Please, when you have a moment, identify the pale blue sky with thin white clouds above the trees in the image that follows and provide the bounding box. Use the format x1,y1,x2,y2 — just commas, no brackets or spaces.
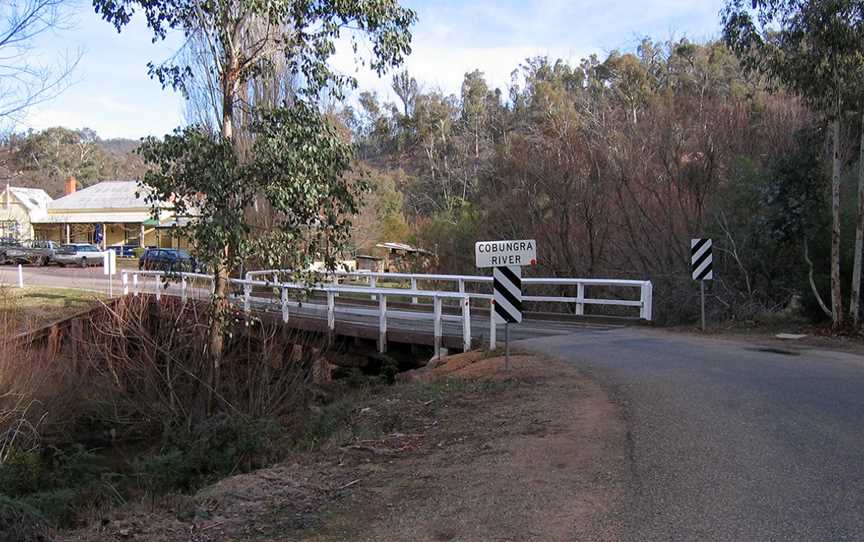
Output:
17,0,723,139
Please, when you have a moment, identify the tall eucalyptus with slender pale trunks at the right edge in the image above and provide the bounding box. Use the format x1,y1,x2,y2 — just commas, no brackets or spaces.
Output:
723,0,864,326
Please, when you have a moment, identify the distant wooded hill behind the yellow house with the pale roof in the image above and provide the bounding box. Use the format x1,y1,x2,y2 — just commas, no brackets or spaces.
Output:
0,127,144,198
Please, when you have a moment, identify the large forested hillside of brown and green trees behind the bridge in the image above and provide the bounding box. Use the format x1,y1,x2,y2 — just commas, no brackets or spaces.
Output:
346,40,840,328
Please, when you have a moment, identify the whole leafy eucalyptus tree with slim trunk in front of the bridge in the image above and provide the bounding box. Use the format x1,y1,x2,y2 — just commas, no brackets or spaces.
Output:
93,0,416,366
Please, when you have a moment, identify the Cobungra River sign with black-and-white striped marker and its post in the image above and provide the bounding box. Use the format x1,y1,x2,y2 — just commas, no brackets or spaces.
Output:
474,239,537,370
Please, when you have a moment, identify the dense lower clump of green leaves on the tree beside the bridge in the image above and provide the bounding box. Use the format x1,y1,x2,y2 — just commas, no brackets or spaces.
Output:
139,101,366,269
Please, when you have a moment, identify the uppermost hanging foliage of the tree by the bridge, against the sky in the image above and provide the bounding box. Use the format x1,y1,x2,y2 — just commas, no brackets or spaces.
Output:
93,0,417,96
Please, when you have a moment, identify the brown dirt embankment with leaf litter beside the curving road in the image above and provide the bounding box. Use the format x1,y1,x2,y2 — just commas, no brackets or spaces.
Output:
64,354,626,542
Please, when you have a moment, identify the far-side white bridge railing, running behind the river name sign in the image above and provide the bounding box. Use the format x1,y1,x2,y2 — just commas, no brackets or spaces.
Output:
246,269,654,321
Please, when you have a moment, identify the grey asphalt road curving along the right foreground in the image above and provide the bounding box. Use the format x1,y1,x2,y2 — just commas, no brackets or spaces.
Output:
518,328,864,542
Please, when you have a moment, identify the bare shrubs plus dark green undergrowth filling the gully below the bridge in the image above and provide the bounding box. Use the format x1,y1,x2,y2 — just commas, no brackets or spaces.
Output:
0,288,460,540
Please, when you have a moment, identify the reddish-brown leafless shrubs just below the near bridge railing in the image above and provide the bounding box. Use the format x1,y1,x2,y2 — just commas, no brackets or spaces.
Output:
0,296,321,462
